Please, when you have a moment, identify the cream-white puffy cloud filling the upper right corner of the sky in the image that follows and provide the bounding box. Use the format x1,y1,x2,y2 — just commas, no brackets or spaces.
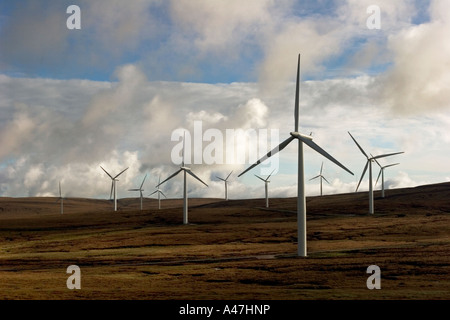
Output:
380,0,450,113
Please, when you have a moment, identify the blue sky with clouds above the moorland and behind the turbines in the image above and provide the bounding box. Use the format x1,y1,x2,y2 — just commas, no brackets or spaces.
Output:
0,0,450,199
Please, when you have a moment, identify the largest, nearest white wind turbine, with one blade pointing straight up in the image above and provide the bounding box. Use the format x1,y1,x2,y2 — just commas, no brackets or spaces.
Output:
239,54,353,257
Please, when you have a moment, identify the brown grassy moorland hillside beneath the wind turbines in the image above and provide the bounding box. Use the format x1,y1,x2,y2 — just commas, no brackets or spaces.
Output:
0,183,450,300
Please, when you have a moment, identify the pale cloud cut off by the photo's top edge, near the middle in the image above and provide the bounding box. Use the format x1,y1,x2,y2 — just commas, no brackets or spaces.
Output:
167,0,276,59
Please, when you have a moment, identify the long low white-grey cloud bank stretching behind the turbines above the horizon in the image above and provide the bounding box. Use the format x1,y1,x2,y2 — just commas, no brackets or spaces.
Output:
0,65,450,197
